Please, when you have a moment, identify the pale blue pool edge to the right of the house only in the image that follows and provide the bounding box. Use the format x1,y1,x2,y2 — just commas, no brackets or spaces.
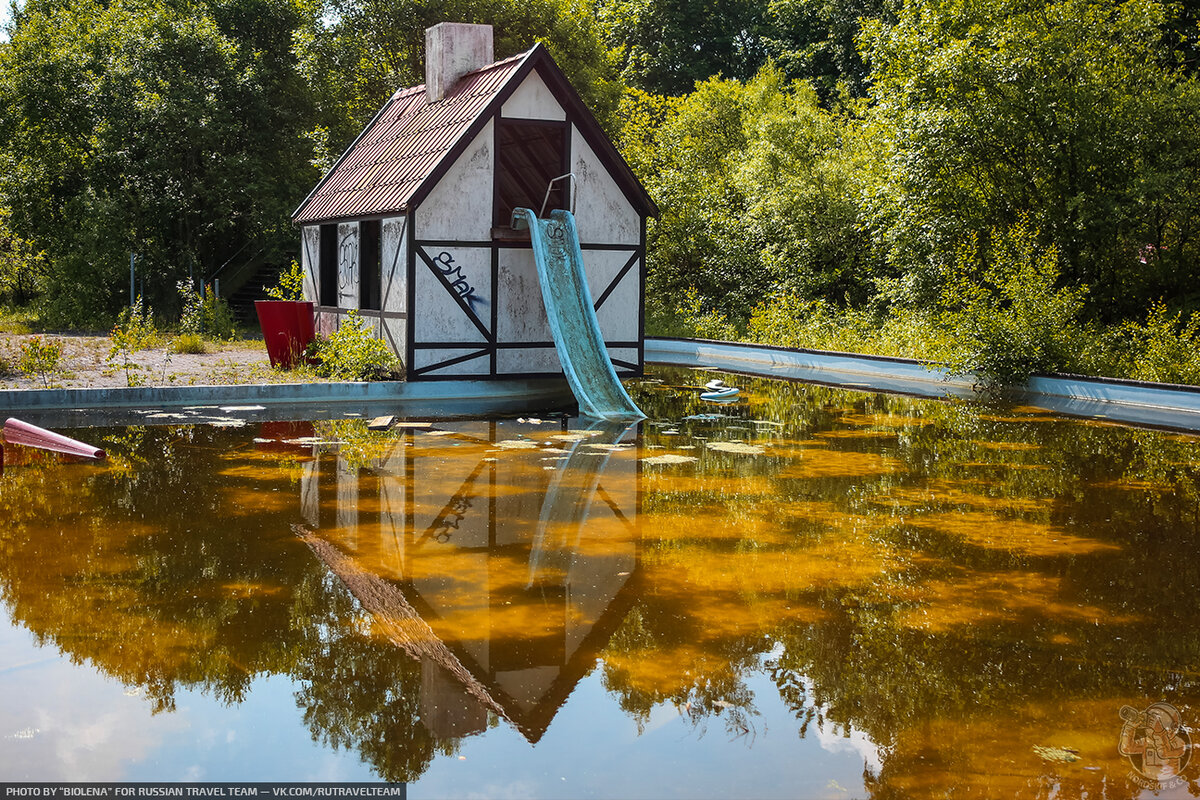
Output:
646,337,1200,431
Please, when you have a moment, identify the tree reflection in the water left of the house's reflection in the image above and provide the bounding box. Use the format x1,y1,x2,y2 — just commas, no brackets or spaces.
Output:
0,427,452,780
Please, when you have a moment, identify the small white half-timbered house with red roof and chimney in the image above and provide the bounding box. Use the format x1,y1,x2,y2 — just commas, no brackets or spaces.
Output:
293,23,656,380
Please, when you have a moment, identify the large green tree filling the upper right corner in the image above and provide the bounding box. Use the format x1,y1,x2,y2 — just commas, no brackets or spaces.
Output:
866,0,1200,317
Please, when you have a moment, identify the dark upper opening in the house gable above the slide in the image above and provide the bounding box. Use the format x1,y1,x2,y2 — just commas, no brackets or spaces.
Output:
492,119,570,228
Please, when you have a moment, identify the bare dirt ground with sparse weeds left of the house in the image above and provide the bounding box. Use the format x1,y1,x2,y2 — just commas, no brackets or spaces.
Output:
0,333,283,390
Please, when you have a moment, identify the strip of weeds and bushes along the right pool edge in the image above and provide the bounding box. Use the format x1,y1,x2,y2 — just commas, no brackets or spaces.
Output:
647,223,1200,389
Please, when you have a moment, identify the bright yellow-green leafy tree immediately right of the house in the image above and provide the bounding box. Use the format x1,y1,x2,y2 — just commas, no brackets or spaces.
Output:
622,66,884,324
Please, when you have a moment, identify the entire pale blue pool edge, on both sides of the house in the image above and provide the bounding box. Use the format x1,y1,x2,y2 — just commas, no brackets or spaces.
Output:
0,337,1200,431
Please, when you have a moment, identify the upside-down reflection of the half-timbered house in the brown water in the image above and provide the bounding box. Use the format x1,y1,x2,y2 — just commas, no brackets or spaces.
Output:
301,422,638,741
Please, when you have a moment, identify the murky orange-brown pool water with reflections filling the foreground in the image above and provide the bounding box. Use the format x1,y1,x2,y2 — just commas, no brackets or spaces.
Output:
0,371,1200,798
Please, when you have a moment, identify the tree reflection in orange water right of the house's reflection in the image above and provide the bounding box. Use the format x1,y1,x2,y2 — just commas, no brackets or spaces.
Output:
619,374,1200,796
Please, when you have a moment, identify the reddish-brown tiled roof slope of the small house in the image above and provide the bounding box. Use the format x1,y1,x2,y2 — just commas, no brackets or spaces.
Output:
292,50,534,224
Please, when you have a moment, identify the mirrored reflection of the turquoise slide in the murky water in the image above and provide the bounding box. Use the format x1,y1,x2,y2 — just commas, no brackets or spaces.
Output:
526,421,636,588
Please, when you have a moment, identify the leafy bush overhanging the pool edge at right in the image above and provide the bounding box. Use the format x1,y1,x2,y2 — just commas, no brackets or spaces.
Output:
941,223,1087,386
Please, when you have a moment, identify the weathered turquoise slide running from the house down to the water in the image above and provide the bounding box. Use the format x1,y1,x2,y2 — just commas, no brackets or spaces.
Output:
512,209,646,420
